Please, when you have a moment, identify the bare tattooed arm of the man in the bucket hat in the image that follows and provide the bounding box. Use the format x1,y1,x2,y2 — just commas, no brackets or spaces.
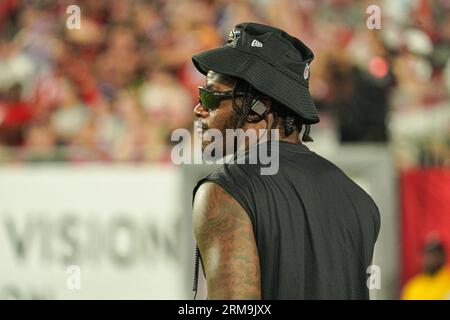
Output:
192,182,261,299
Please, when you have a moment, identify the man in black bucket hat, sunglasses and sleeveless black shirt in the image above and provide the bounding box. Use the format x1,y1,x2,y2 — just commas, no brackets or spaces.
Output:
192,23,380,299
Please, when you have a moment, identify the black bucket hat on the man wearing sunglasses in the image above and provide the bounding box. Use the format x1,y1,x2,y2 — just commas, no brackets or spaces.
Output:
192,22,319,124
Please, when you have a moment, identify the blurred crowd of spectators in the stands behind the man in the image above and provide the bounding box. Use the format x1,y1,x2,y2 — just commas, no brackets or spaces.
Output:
0,0,450,164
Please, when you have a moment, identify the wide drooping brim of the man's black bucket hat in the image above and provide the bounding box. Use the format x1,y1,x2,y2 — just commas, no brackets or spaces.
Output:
192,45,319,124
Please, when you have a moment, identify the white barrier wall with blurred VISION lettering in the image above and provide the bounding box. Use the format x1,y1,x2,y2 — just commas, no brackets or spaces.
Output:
0,165,186,299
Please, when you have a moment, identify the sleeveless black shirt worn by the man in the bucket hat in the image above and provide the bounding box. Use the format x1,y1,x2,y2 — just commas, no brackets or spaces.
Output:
194,141,380,299
